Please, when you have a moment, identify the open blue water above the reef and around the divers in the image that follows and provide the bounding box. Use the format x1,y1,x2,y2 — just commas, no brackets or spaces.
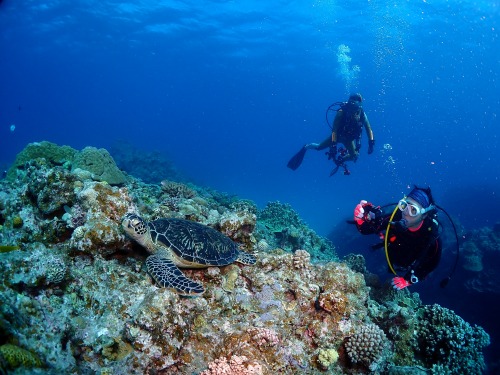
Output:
0,0,500,370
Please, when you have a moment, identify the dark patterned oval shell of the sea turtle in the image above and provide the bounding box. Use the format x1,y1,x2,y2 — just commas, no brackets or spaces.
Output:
148,219,240,266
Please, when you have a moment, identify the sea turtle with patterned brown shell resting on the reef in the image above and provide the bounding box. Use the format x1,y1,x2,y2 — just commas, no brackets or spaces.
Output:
122,214,256,295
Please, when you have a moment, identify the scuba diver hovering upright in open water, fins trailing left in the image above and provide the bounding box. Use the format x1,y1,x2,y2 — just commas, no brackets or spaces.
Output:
288,93,375,176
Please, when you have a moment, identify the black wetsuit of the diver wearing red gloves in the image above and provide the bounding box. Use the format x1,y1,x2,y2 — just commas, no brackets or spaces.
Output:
356,210,442,282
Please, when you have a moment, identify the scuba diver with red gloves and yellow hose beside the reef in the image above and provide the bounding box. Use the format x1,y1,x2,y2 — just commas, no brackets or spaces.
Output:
354,186,444,290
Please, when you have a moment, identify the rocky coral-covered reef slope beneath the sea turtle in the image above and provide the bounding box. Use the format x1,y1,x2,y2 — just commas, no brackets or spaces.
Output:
0,142,489,375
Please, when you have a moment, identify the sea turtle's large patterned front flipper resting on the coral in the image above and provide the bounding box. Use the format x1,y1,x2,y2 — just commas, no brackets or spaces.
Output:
146,254,205,296
